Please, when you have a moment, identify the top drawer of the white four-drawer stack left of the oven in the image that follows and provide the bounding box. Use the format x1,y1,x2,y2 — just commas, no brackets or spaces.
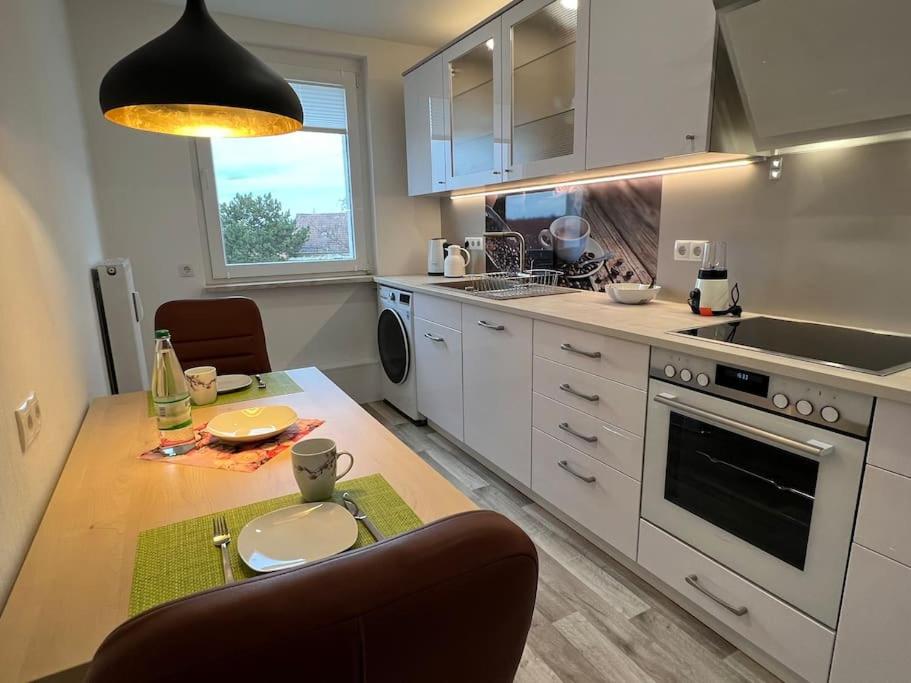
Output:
535,321,649,389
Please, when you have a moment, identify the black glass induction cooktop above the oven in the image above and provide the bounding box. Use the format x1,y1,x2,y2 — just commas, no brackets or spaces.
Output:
675,316,911,375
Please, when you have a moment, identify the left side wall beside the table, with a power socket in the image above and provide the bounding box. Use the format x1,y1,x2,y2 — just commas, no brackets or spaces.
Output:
0,0,106,604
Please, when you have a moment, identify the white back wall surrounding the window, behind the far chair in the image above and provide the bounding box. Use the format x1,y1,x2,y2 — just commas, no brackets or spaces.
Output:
68,0,440,400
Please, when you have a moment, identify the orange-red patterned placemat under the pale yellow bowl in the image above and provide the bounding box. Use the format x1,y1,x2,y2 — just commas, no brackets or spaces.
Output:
139,419,323,472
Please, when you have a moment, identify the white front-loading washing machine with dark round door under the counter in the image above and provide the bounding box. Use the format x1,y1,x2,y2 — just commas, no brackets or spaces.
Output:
376,285,424,422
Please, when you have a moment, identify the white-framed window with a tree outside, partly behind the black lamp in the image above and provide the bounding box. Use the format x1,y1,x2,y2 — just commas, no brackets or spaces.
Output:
196,58,369,280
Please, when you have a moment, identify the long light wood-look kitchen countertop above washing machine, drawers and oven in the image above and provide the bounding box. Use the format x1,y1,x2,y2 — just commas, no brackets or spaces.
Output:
374,275,911,403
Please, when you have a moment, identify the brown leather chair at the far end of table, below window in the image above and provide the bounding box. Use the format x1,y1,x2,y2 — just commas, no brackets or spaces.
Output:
155,296,272,375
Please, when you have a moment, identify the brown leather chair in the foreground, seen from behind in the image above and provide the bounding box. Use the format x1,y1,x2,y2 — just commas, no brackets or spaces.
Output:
86,510,538,683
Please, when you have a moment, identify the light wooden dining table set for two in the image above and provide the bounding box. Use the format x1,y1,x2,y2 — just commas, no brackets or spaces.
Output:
0,368,475,681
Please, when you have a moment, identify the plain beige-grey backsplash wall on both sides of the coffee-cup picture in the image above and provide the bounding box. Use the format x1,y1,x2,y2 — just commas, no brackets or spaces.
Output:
442,141,911,333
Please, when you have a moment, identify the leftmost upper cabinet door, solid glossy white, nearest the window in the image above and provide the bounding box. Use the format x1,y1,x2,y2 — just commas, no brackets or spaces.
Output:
405,55,449,197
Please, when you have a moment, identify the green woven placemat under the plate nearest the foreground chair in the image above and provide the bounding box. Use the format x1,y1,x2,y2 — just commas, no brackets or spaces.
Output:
129,474,423,617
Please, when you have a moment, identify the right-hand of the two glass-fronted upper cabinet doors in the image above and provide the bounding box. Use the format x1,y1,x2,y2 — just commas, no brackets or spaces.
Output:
501,0,589,180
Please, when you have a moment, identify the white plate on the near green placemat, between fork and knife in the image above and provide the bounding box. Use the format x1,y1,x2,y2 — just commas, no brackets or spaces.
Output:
237,503,357,572
